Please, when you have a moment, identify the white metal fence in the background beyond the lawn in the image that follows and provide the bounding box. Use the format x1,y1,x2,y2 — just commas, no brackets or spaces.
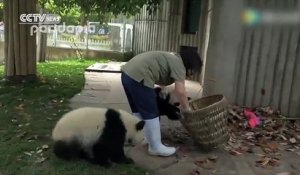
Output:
0,22,133,52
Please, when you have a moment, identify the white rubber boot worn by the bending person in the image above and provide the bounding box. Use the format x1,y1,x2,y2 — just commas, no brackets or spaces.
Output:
144,117,176,156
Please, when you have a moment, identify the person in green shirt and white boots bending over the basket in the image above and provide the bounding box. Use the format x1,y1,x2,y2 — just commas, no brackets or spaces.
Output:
121,51,202,156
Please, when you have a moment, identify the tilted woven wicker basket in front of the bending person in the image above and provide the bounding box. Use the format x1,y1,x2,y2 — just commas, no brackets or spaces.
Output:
180,95,229,150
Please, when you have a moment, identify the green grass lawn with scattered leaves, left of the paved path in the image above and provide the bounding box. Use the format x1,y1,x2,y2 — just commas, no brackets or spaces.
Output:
0,60,145,175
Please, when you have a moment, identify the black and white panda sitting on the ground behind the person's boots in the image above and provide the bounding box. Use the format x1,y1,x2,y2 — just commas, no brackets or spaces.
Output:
52,107,145,167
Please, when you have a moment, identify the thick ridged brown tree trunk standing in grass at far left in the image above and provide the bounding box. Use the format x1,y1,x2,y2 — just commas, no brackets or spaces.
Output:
4,0,36,83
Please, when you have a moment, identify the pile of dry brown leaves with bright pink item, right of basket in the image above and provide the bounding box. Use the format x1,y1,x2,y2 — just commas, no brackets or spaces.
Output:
225,106,300,168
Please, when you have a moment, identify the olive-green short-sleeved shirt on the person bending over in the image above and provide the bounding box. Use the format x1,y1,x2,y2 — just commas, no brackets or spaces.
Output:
121,51,185,88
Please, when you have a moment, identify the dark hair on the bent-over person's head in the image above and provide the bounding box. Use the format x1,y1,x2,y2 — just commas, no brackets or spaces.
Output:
179,50,203,76
